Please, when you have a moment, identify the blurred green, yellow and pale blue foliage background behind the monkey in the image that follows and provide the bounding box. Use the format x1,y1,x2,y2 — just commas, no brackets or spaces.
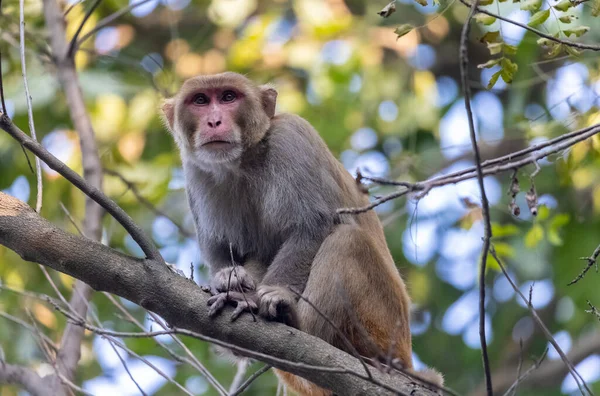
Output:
0,0,600,395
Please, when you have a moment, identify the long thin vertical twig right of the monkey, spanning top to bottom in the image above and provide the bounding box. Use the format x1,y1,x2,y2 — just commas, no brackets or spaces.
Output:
460,0,494,396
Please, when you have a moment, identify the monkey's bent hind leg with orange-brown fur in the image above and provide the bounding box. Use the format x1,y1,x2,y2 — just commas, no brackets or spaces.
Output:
278,225,412,396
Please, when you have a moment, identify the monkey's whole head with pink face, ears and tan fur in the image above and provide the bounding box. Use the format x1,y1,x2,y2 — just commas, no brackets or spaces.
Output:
162,72,277,169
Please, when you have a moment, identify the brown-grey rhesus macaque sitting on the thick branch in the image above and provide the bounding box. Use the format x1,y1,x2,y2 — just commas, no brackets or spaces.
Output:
163,72,443,396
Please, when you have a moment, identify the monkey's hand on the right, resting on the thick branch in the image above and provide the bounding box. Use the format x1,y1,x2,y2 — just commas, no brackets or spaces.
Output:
257,285,298,328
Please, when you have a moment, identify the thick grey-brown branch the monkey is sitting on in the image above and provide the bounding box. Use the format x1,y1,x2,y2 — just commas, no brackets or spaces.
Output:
0,193,435,395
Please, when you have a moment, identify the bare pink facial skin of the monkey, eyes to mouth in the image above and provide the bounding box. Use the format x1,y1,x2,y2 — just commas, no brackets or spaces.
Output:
185,88,244,154
